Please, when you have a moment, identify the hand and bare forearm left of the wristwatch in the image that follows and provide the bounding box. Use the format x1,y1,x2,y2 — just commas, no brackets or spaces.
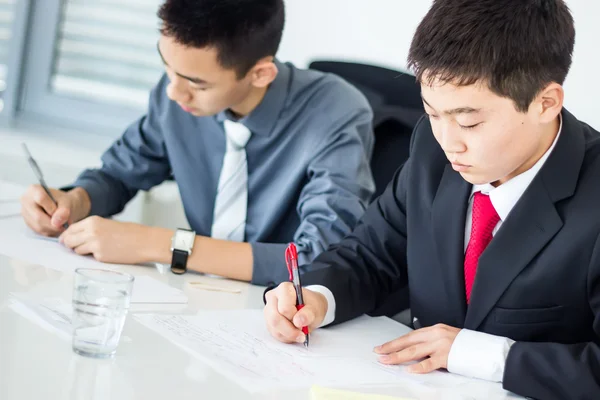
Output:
59,216,159,264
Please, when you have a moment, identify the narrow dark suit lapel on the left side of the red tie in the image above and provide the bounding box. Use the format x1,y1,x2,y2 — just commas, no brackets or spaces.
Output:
432,165,472,327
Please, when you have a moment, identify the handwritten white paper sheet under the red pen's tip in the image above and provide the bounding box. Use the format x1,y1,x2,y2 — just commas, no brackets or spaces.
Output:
134,310,494,392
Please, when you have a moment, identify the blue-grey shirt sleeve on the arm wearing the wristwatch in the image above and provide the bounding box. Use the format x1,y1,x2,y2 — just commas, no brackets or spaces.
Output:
252,94,375,285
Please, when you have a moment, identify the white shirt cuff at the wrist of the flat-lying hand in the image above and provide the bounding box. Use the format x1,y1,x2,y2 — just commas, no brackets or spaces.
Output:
448,329,515,382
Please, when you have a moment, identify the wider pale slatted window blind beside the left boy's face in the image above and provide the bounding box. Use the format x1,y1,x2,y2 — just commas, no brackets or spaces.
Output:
50,0,163,108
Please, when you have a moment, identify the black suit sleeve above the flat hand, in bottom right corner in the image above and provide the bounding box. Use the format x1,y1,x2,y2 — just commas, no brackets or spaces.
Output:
503,236,600,400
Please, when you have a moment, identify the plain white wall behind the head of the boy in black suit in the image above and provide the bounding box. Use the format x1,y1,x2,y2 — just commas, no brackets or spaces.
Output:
279,0,600,129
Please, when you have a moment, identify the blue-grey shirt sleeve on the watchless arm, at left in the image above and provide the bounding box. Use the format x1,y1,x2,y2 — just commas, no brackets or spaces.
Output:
72,76,171,217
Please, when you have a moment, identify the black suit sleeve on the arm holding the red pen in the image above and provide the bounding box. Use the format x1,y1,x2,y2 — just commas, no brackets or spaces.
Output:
302,117,418,323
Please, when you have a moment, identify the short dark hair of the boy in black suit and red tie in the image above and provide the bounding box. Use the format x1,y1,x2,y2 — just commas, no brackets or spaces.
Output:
408,0,575,112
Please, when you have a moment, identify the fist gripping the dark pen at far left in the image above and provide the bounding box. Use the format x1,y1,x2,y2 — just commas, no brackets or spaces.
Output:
21,185,91,236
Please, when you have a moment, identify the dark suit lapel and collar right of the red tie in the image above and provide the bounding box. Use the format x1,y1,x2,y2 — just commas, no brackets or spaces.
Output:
464,109,585,330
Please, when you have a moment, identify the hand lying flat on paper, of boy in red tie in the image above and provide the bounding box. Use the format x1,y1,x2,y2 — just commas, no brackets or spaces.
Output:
374,324,460,374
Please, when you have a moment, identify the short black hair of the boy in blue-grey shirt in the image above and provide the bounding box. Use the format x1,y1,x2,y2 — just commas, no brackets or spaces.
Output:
158,0,285,78
